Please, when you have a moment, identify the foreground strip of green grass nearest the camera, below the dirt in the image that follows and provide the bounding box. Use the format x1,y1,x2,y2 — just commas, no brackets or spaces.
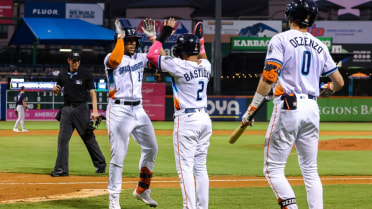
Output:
0,185,372,209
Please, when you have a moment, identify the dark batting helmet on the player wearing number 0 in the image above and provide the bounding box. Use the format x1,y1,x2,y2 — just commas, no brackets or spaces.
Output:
285,0,318,27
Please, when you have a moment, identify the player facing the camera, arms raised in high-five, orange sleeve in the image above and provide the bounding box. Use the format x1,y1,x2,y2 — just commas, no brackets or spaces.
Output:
104,19,165,209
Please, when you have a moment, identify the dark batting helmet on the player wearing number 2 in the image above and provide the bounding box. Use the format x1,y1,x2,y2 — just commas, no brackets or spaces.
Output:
173,34,200,57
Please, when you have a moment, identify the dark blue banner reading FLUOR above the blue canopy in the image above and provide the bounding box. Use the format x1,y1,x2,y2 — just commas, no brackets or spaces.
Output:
24,1,66,18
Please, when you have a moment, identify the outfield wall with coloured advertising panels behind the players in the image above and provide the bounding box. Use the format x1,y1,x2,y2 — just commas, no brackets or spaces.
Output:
0,85,372,122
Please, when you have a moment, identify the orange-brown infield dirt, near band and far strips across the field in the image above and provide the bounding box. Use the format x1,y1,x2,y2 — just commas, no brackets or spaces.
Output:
0,130,372,203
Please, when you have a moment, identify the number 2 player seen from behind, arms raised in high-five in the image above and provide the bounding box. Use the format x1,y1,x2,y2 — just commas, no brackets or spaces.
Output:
147,18,212,209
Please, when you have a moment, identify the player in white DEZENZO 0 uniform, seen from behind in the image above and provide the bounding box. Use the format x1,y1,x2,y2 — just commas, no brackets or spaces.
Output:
242,0,344,209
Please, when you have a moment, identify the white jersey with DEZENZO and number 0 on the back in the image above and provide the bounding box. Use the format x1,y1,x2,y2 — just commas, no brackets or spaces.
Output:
265,30,337,96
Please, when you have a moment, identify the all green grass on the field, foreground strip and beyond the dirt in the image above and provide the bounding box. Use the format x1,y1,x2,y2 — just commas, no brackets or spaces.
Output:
0,121,372,209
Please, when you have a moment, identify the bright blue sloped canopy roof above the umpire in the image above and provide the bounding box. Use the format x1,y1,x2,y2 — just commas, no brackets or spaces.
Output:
9,17,115,64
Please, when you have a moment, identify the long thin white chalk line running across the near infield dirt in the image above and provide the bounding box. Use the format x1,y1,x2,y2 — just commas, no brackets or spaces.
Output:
0,177,372,185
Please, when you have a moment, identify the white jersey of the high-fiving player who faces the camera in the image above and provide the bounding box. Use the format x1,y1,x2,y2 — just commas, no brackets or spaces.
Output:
104,53,148,101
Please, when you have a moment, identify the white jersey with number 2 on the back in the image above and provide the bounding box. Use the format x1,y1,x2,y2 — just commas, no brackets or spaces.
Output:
159,56,211,110
